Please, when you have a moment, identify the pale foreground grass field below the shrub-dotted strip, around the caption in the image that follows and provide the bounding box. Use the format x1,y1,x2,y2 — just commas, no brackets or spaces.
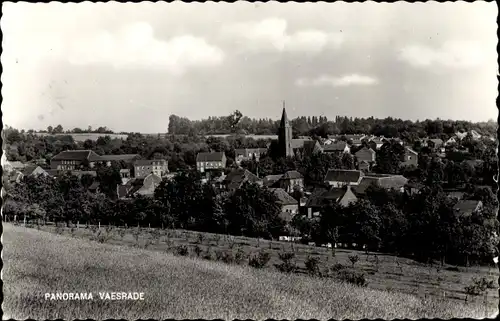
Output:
2,223,496,319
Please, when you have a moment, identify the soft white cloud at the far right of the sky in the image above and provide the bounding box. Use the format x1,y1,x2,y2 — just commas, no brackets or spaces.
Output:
399,41,486,68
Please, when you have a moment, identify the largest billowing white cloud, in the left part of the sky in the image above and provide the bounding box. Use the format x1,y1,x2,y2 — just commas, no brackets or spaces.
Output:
69,22,224,73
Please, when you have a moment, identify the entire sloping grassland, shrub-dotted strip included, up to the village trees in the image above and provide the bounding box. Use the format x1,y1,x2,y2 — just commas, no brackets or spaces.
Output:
2,223,498,319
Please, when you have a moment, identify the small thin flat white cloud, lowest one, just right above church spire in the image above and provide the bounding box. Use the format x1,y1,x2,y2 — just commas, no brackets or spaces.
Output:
295,74,378,87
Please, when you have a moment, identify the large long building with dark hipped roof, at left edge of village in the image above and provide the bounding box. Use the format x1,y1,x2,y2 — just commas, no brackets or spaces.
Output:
50,150,101,171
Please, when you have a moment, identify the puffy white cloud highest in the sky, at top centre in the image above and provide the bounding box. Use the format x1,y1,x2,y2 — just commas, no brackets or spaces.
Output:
221,18,343,53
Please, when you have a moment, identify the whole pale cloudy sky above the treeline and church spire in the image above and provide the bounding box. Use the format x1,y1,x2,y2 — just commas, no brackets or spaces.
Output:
0,1,498,133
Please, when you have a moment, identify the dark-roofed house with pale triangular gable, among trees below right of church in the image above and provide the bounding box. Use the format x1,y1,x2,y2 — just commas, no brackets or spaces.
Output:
304,185,358,218
